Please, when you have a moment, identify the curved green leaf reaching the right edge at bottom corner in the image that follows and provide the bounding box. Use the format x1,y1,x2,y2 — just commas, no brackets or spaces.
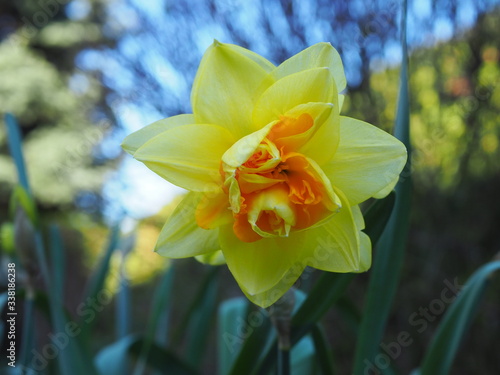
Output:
420,261,500,375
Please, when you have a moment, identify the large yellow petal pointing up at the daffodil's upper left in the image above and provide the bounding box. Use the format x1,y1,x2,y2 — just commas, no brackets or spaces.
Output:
191,42,273,138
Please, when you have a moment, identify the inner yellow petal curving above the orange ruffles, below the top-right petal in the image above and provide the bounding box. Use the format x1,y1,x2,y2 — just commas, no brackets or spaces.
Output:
253,68,338,130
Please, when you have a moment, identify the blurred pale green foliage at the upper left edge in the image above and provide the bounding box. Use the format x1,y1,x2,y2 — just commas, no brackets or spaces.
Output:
0,7,111,207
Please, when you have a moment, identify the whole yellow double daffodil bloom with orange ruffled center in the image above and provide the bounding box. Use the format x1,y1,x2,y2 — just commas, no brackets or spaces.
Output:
123,41,406,307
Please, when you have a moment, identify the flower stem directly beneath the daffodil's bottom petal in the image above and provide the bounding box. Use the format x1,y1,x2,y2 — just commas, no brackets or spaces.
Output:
268,289,295,375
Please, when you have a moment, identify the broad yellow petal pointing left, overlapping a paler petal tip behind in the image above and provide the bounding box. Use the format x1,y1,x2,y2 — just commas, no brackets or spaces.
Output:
134,124,234,191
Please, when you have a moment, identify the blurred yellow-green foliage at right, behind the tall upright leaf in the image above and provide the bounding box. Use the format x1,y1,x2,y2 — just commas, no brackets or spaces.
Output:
346,10,500,191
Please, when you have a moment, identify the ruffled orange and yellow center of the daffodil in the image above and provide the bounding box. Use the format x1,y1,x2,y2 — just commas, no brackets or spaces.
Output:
215,113,340,242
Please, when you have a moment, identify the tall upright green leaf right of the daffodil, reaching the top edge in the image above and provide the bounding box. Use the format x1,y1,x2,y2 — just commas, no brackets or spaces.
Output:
354,0,411,375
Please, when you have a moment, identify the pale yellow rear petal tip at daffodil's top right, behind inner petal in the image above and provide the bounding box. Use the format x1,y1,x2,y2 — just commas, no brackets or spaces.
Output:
273,43,346,92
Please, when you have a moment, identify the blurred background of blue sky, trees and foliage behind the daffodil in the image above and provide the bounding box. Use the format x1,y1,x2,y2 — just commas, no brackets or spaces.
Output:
0,0,500,374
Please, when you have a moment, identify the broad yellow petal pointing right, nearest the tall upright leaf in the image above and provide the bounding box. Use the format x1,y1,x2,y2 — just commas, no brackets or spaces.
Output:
321,116,407,205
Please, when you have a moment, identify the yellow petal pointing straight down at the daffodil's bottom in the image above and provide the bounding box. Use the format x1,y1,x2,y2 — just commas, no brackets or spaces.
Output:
219,225,306,295
